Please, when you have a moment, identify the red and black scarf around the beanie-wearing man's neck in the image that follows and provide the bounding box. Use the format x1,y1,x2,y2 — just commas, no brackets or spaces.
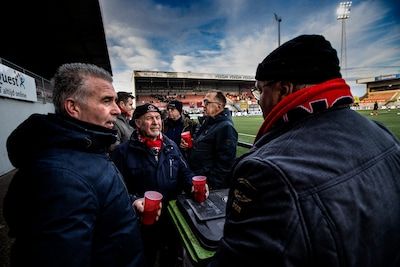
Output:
255,78,353,141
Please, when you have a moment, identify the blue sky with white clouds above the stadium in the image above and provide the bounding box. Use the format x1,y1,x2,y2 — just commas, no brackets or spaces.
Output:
100,0,400,96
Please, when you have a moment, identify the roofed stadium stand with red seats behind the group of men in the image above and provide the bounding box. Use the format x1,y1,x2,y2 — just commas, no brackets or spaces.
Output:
133,71,255,114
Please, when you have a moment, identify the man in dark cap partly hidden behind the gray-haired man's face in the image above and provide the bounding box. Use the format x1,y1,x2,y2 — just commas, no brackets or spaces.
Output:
114,92,135,149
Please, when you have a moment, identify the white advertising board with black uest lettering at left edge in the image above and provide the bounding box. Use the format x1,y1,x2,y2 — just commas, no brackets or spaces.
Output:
0,64,37,102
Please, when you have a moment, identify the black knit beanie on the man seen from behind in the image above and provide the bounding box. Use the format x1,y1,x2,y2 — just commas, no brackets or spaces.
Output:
256,35,342,84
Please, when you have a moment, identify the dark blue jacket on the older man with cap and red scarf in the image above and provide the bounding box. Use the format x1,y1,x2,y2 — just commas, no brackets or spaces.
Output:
111,130,193,204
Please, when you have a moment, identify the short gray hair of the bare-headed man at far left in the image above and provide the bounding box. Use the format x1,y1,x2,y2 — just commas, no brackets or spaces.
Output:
51,63,113,114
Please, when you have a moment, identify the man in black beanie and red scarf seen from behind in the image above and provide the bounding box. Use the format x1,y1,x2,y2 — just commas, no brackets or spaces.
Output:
209,35,400,267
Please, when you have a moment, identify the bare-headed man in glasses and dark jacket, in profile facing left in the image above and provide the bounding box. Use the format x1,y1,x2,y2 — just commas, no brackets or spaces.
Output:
187,91,238,190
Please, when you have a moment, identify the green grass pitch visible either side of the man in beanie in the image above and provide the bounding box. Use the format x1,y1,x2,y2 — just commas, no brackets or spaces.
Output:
233,110,400,156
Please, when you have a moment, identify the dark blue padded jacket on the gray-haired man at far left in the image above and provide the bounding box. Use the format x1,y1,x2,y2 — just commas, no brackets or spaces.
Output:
4,114,143,267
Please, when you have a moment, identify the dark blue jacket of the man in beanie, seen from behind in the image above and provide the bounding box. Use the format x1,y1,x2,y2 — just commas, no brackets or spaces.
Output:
211,108,400,267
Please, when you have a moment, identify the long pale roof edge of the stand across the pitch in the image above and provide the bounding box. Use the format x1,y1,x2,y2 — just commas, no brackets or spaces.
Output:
133,70,255,81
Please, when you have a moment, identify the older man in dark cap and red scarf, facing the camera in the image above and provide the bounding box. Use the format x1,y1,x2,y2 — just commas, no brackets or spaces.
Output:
111,104,197,267
